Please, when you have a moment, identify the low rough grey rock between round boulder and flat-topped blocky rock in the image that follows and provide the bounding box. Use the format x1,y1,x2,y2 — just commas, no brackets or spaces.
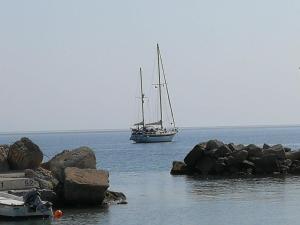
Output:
25,167,59,190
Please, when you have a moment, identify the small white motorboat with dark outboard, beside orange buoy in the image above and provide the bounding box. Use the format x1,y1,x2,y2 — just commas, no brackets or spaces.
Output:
0,190,53,219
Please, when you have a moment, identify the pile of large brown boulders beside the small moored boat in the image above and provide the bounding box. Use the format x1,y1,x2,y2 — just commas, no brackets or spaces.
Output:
0,138,126,206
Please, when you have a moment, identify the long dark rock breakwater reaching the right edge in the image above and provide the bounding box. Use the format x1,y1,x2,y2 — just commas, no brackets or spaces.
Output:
171,140,300,177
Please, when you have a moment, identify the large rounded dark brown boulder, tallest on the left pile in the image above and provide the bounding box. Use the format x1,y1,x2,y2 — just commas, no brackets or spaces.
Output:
8,137,43,170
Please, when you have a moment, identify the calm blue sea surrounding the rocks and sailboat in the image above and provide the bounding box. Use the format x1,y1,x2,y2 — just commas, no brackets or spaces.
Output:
0,126,300,225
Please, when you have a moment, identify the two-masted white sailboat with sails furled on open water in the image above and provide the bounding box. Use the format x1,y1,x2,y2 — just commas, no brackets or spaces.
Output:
130,44,178,143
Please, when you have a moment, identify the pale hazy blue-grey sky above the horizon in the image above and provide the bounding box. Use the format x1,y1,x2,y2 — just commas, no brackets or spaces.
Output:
0,0,300,132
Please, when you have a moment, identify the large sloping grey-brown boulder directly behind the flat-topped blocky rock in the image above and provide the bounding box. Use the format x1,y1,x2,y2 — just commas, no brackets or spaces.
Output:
47,147,96,182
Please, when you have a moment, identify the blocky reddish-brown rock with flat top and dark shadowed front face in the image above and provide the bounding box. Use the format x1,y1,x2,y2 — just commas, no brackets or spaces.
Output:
64,167,109,205
